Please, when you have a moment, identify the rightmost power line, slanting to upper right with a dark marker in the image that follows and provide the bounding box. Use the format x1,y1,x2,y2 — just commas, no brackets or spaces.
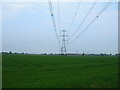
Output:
70,2,111,43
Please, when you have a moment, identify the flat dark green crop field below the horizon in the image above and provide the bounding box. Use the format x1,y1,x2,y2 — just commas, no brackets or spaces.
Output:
2,54,118,88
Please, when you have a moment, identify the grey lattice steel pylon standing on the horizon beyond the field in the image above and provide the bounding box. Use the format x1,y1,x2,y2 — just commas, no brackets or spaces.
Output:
60,29,68,55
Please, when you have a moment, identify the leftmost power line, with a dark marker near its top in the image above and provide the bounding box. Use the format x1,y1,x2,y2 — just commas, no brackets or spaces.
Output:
48,0,60,45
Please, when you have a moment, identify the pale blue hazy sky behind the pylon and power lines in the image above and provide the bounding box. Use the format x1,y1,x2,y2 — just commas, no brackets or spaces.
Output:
2,2,118,54
